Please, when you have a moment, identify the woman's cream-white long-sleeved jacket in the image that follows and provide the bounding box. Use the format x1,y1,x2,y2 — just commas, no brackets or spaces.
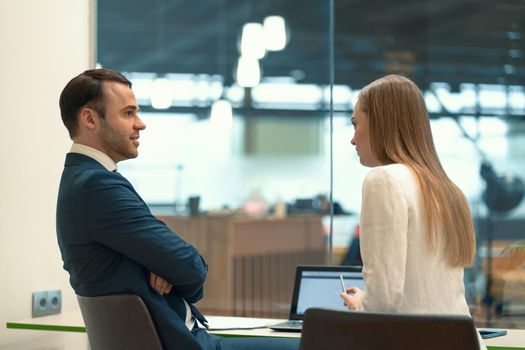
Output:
360,164,470,315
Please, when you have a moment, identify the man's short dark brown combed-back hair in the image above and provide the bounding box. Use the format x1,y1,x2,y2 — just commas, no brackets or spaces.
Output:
59,69,131,138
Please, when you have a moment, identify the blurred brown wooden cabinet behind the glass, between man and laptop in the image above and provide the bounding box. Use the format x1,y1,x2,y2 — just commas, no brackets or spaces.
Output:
159,215,325,317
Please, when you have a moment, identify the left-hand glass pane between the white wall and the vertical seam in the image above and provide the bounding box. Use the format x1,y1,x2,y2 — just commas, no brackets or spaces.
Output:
98,0,332,317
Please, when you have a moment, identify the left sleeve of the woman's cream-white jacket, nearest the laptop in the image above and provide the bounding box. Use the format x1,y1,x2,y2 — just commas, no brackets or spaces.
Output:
359,168,408,312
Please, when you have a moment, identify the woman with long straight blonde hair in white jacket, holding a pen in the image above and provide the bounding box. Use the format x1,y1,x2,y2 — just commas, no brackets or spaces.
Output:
341,75,475,326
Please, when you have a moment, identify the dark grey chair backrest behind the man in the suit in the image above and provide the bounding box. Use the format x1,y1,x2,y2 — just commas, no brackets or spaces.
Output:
77,294,162,350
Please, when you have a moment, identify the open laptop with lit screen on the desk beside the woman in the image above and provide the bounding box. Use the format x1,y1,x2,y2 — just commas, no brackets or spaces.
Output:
268,266,366,332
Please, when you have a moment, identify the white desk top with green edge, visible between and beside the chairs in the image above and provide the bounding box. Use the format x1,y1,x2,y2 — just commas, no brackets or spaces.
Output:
6,311,525,350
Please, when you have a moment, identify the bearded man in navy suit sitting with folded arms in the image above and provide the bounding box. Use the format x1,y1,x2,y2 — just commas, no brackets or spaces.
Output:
57,69,298,350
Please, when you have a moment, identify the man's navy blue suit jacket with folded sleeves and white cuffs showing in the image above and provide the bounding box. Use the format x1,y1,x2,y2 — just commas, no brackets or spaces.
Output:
57,153,208,349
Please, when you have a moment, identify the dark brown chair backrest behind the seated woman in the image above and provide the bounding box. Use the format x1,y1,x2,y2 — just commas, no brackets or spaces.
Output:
301,308,479,350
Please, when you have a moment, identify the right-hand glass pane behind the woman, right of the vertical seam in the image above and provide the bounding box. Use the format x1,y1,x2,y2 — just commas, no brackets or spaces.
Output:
333,0,525,328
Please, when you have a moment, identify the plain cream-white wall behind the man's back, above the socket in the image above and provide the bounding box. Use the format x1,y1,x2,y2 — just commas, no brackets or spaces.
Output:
0,0,93,345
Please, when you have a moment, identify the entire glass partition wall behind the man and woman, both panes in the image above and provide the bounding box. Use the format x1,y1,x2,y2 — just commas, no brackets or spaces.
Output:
97,0,525,328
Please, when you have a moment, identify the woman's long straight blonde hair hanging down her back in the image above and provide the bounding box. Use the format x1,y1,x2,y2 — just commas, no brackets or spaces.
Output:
359,75,476,267
